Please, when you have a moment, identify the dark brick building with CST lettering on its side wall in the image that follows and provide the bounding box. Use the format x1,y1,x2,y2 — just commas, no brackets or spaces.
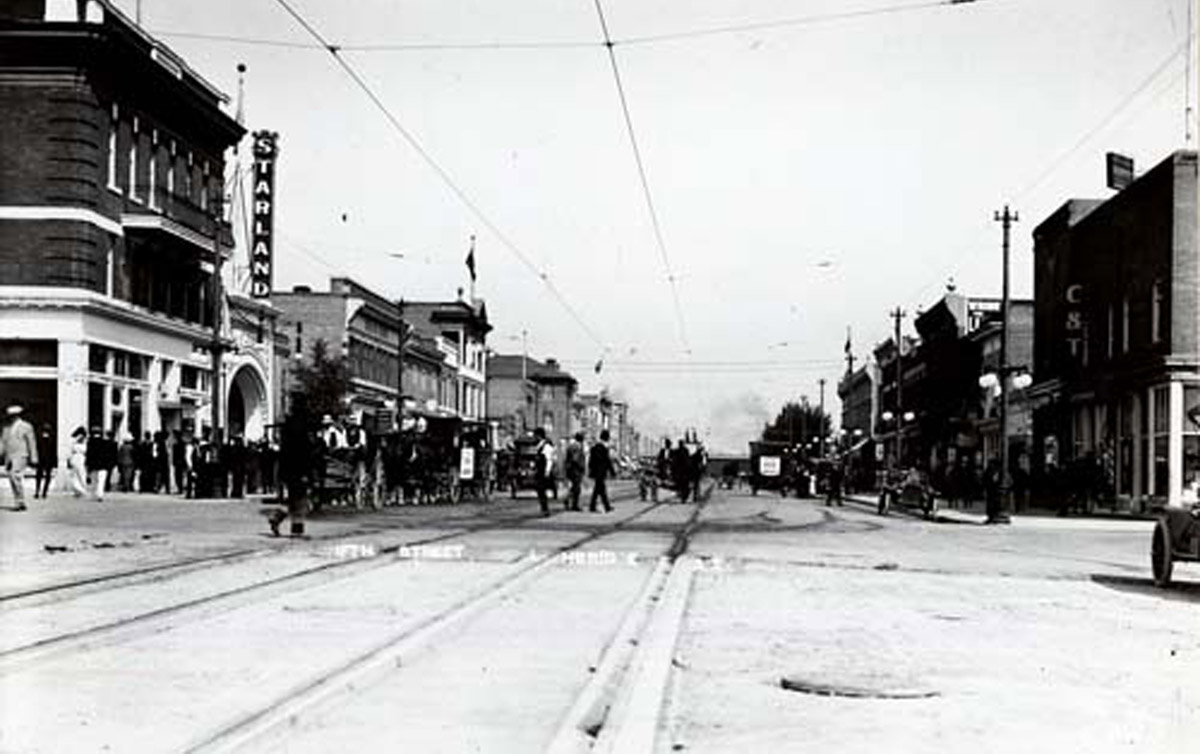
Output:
1032,151,1200,507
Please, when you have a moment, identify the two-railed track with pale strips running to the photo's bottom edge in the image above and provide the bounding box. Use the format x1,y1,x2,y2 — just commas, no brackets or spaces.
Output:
186,492,703,754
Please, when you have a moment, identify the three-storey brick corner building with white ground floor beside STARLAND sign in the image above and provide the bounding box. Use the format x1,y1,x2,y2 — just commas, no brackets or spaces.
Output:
0,0,248,459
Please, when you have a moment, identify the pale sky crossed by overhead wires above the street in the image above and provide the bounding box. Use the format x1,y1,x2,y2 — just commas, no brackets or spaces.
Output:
116,0,1196,451
